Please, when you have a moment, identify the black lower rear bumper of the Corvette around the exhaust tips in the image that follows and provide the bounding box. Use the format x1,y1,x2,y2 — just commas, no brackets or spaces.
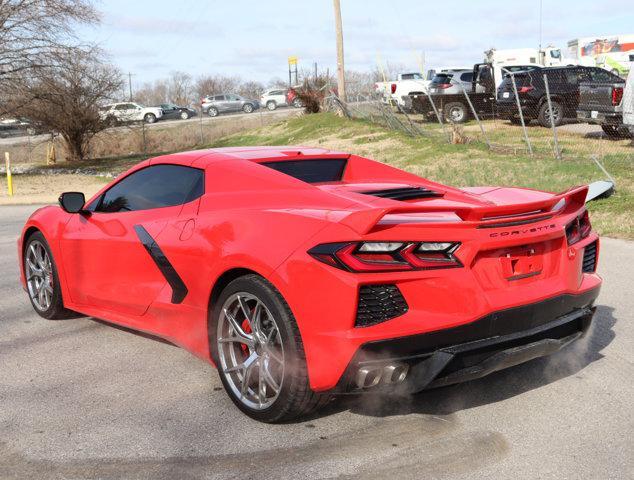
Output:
331,287,600,393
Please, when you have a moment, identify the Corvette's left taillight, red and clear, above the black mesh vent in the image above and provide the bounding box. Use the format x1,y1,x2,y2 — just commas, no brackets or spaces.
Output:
308,242,462,272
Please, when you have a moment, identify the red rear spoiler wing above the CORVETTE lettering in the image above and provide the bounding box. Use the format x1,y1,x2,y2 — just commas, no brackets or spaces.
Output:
339,185,588,235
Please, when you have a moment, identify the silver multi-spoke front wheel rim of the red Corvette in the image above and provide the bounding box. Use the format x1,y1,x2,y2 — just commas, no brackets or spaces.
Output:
24,240,54,312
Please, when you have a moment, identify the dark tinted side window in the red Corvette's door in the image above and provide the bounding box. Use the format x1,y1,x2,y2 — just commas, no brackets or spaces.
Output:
95,165,205,212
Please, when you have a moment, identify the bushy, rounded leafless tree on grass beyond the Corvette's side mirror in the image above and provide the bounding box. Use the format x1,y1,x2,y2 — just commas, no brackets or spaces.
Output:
9,49,123,162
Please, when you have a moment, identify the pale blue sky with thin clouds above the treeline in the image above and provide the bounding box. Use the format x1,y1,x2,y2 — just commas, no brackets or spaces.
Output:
78,0,634,85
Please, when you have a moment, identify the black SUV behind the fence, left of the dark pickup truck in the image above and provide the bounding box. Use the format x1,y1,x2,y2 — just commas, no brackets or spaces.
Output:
497,66,606,127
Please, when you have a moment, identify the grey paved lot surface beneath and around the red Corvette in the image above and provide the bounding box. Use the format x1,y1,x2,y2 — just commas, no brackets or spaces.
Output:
0,206,634,479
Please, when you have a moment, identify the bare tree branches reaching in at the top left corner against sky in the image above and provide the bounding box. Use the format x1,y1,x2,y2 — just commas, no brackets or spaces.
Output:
0,0,99,113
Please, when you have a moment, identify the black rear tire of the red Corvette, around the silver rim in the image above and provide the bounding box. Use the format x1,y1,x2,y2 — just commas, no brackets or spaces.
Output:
209,275,330,423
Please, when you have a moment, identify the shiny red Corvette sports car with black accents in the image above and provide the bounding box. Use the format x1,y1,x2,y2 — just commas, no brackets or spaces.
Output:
18,147,601,422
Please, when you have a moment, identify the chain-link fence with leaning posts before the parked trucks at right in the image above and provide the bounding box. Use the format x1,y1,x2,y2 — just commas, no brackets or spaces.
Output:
348,64,634,167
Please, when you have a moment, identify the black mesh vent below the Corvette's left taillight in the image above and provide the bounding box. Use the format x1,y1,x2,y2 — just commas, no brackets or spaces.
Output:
355,285,408,327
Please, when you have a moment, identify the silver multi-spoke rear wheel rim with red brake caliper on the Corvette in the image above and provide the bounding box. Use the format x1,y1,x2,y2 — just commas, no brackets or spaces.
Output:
217,292,284,410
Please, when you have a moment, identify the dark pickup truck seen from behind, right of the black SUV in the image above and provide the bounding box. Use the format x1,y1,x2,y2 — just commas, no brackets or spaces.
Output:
577,70,631,137
